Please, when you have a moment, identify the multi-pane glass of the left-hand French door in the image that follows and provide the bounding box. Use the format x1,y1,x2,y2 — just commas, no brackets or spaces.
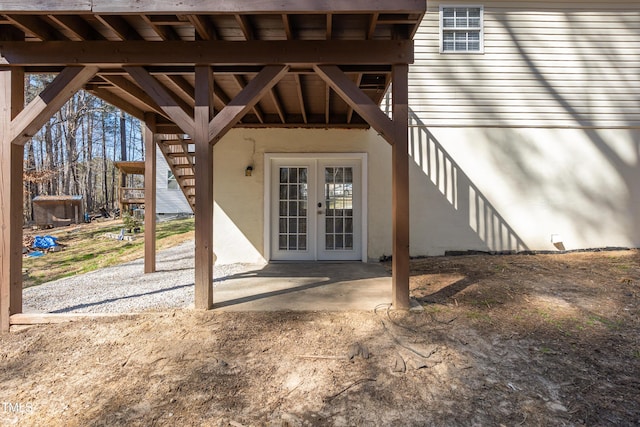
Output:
278,167,308,251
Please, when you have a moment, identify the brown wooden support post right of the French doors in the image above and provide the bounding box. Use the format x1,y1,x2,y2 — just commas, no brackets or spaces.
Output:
391,64,409,310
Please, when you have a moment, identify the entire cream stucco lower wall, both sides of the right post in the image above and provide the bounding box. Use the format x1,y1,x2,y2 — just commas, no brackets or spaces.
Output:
214,123,640,263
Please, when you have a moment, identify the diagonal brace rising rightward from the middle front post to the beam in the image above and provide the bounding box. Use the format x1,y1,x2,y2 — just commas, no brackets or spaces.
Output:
210,65,289,144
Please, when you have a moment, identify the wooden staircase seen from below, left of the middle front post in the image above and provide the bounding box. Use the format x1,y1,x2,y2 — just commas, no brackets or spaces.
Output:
158,135,196,213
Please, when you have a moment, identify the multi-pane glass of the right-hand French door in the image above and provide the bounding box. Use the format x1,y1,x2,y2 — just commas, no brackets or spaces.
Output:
324,167,353,251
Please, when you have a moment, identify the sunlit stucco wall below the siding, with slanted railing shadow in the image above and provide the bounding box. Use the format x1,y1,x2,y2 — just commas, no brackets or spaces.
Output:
411,127,640,255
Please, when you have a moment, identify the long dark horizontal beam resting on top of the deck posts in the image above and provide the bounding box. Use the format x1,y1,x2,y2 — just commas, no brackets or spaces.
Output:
0,40,413,66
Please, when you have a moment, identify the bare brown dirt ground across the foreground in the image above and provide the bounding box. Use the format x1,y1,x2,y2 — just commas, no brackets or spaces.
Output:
0,251,640,426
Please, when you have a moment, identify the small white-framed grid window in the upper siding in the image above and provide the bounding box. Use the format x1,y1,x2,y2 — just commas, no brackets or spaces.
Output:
440,6,484,53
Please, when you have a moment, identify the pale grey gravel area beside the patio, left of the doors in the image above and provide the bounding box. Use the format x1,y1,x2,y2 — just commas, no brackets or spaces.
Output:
23,241,262,313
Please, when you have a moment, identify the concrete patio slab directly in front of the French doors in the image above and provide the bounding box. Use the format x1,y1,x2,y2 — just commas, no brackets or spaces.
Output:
213,262,391,311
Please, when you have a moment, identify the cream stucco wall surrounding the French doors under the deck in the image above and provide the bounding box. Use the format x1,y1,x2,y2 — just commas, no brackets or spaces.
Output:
214,129,391,263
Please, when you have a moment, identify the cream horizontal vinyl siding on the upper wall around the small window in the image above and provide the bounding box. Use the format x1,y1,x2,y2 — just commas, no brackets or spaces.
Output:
409,0,640,128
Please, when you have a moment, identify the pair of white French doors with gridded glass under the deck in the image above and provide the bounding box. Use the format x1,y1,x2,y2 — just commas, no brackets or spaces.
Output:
269,156,363,260
